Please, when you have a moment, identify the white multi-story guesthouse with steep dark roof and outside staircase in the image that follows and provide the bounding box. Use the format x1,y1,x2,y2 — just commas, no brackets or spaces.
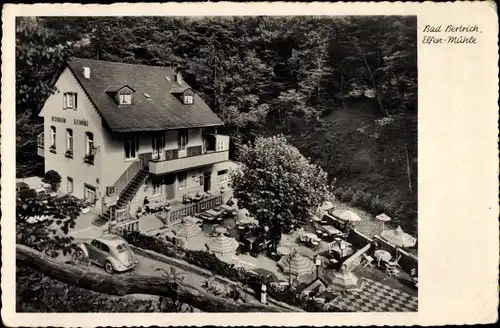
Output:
39,58,230,219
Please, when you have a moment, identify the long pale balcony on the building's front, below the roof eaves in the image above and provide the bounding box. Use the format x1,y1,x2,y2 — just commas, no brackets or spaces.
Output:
149,147,229,174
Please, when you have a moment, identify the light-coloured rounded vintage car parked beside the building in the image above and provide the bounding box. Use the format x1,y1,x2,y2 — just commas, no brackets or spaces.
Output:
76,234,139,273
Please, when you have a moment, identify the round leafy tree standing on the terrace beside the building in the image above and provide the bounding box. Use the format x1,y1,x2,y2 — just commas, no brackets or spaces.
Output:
232,136,328,246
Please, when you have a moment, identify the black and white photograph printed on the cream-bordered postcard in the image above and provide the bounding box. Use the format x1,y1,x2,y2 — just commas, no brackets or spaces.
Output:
12,16,418,313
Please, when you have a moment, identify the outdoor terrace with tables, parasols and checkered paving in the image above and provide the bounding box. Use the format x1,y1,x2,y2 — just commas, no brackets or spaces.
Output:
130,195,418,312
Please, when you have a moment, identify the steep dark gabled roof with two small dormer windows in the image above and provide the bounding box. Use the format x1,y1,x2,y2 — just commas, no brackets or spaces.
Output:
68,57,223,132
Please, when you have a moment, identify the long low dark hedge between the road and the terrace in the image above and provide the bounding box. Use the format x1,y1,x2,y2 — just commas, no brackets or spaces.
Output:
123,231,342,312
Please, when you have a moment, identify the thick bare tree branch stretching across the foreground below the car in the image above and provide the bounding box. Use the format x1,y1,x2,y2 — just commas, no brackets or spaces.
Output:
16,244,292,312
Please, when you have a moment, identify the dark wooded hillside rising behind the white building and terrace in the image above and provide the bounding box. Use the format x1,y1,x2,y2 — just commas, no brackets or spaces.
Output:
16,16,417,234
